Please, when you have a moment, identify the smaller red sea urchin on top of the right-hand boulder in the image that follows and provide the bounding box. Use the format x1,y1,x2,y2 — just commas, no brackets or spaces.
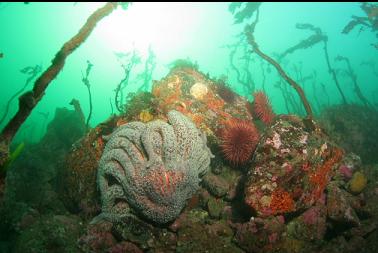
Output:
253,91,275,125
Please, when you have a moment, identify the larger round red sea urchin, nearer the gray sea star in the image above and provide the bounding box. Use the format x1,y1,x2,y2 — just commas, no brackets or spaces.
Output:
220,119,259,165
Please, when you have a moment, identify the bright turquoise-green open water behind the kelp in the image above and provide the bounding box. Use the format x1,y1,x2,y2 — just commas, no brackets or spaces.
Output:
0,3,378,142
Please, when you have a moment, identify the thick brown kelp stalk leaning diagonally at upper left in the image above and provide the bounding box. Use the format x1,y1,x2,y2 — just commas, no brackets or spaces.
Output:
0,2,128,170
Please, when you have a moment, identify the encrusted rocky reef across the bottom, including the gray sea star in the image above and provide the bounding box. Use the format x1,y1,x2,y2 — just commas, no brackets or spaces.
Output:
0,65,378,253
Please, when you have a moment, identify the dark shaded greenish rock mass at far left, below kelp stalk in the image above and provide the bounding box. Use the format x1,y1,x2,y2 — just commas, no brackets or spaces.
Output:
0,108,86,252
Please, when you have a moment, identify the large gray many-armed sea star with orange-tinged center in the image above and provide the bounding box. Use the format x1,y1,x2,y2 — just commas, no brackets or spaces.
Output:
98,111,213,223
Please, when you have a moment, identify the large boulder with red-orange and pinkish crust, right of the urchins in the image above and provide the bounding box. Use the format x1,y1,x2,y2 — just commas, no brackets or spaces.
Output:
245,116,343,217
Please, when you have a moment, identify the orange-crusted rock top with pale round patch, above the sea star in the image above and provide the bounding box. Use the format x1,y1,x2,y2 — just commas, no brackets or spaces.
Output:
152,64,252,136
